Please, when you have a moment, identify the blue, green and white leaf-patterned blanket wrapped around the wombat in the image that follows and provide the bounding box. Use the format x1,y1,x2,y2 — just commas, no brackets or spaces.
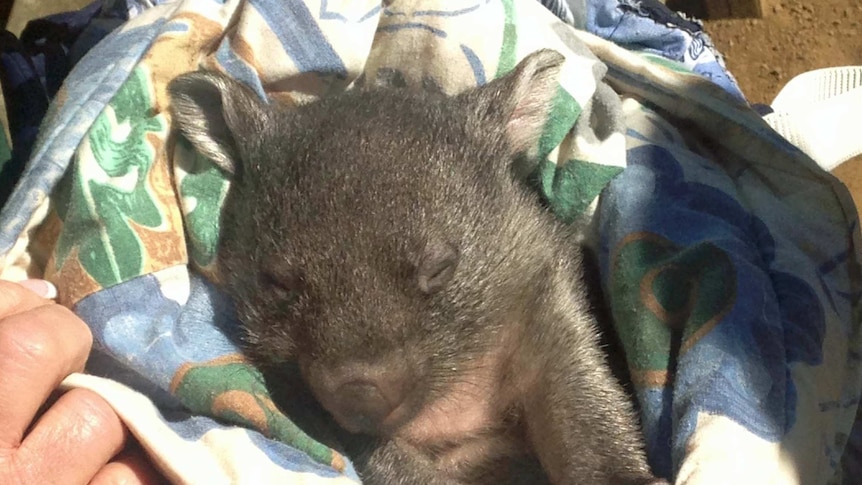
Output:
0,0,862,484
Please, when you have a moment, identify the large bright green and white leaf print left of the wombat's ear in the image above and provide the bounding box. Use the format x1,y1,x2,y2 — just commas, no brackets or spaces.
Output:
55,67,167,287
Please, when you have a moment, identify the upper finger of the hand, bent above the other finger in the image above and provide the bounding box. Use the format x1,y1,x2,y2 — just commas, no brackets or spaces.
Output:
0,304,93,450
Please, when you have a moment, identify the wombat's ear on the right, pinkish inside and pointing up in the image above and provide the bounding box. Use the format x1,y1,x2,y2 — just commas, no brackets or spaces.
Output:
465,49,566,156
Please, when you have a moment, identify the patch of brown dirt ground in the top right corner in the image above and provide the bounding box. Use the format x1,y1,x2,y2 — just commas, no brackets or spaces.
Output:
704,0,862,104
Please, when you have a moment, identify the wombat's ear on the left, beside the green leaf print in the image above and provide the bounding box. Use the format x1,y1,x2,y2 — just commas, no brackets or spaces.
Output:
168,71,268,175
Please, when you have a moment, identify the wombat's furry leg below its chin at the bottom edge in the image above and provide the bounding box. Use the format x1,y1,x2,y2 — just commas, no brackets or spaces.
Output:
353,439,464,485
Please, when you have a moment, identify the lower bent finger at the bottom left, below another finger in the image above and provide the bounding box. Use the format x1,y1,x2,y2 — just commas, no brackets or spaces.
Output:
14,389,128,484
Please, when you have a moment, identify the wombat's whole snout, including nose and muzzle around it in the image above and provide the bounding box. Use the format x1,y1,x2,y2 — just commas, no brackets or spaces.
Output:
309,362,416,434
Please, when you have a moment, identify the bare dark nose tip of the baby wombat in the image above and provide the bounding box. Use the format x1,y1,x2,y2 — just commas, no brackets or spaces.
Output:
334,381,399,433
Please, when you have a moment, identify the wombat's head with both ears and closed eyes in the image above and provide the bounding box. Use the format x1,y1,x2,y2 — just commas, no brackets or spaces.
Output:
169,51,563,433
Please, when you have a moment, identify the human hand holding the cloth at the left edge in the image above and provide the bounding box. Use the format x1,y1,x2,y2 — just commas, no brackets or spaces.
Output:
0,280,164,485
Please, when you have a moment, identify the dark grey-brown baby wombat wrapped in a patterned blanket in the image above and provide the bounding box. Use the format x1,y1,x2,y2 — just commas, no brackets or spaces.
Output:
169,50,664,485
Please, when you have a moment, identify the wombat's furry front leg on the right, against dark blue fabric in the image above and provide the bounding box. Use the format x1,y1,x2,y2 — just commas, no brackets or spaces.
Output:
518,264,666,485
